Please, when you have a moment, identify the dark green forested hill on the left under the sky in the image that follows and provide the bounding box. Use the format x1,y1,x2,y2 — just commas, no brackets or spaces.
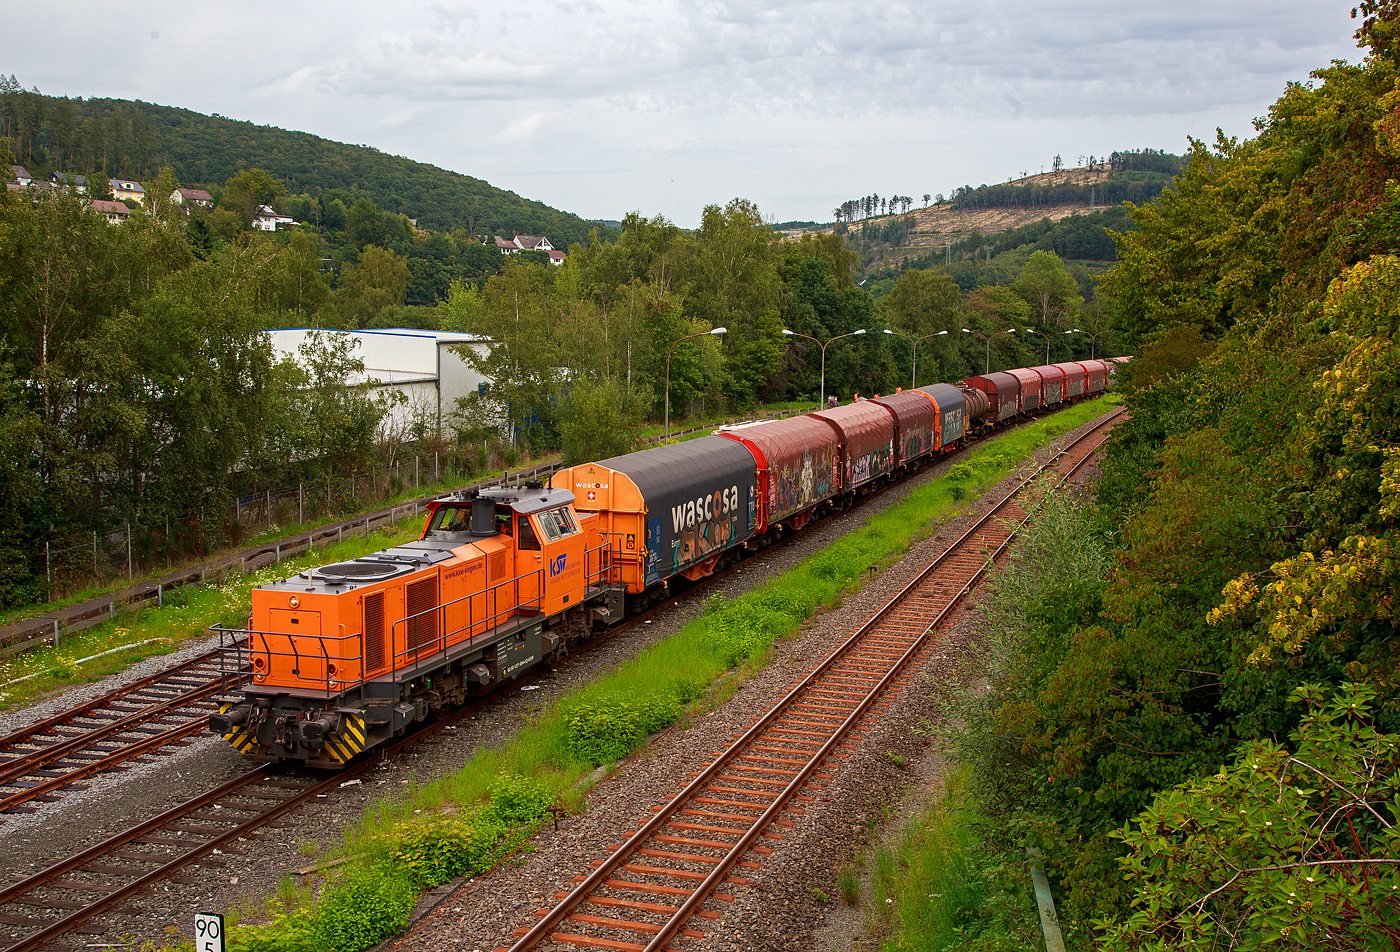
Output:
0,83,592,248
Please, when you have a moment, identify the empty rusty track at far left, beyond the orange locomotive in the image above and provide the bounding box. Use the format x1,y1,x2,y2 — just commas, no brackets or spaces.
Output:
0,651,243,822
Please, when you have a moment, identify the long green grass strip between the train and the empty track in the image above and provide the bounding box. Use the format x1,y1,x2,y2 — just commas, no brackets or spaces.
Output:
221,402,1103,952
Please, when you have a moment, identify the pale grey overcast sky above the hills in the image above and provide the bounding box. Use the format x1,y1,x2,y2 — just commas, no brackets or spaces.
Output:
0,0,1359,227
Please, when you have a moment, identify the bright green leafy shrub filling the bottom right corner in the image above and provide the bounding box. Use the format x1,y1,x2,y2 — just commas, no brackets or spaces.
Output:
1098,685,1400,952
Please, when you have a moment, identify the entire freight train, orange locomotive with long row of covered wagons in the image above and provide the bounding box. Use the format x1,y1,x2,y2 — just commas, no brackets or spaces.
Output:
209,361,1117,769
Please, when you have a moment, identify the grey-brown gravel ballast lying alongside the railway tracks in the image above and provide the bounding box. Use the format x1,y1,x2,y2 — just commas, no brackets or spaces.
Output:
0,411,1114,952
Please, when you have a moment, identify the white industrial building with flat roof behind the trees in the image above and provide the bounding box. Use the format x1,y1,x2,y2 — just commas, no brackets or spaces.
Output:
267,328,490,433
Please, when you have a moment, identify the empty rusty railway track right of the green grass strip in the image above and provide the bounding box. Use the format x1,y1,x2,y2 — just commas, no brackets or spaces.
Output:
496,414,1119,952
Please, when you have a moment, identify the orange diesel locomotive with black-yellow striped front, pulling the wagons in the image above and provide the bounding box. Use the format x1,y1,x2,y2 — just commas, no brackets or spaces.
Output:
209,483,622,767
